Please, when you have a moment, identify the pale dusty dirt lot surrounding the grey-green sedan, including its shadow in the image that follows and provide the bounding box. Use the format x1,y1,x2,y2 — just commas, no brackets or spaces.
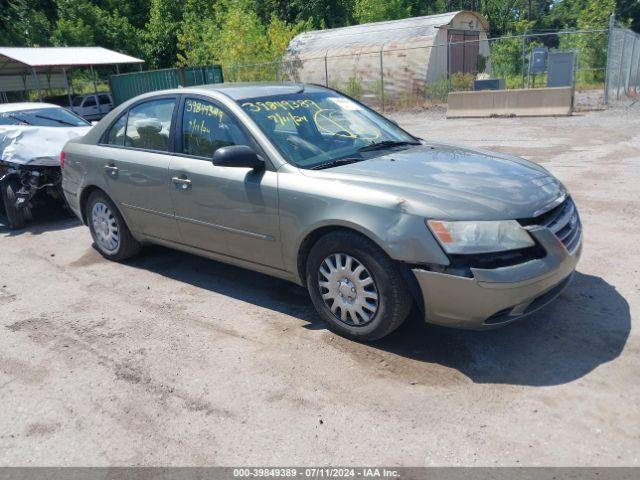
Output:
0,101,640,466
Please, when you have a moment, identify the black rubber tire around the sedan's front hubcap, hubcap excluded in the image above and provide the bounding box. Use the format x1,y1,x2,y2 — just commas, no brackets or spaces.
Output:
306,230,413,342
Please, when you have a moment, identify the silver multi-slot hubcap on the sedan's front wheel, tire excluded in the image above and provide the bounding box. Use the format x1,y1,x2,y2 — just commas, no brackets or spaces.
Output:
318,253,378,326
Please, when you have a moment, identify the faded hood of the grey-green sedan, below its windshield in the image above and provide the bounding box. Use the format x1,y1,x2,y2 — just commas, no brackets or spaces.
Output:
303,144,566,220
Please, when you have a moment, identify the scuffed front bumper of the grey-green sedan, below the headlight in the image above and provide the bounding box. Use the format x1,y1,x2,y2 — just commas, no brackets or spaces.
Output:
413,227,582,330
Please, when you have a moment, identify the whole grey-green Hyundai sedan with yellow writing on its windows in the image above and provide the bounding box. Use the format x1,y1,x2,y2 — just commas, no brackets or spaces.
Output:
61,84,582,341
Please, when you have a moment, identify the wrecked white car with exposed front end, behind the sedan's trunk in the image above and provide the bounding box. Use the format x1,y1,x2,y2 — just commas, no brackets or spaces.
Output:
0,103,91,228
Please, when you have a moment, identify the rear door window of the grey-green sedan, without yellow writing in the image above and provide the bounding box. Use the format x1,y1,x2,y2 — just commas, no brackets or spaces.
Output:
125,98,176,152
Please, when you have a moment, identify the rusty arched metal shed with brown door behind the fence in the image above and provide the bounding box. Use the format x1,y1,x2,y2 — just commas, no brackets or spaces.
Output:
285,11,490,100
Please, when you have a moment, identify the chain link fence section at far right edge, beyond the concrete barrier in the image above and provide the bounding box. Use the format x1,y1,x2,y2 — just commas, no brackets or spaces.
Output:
605,17,640,103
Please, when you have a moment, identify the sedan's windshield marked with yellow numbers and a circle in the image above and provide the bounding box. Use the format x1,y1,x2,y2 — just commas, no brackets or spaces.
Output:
239,91,419,169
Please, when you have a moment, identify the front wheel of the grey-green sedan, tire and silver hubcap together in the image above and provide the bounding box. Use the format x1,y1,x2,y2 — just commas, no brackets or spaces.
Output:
306,231,412,341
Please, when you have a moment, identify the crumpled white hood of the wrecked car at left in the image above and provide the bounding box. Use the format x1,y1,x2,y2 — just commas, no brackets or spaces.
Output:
0,125,91,167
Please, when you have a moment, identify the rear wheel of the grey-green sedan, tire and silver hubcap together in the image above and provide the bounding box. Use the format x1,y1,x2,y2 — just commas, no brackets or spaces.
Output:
85,191,142,261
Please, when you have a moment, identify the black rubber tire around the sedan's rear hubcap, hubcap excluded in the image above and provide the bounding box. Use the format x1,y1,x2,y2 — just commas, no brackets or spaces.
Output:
85,190,142,262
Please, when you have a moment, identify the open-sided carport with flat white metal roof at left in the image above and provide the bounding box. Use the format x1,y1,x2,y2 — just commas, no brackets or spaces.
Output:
0,47,144,103
